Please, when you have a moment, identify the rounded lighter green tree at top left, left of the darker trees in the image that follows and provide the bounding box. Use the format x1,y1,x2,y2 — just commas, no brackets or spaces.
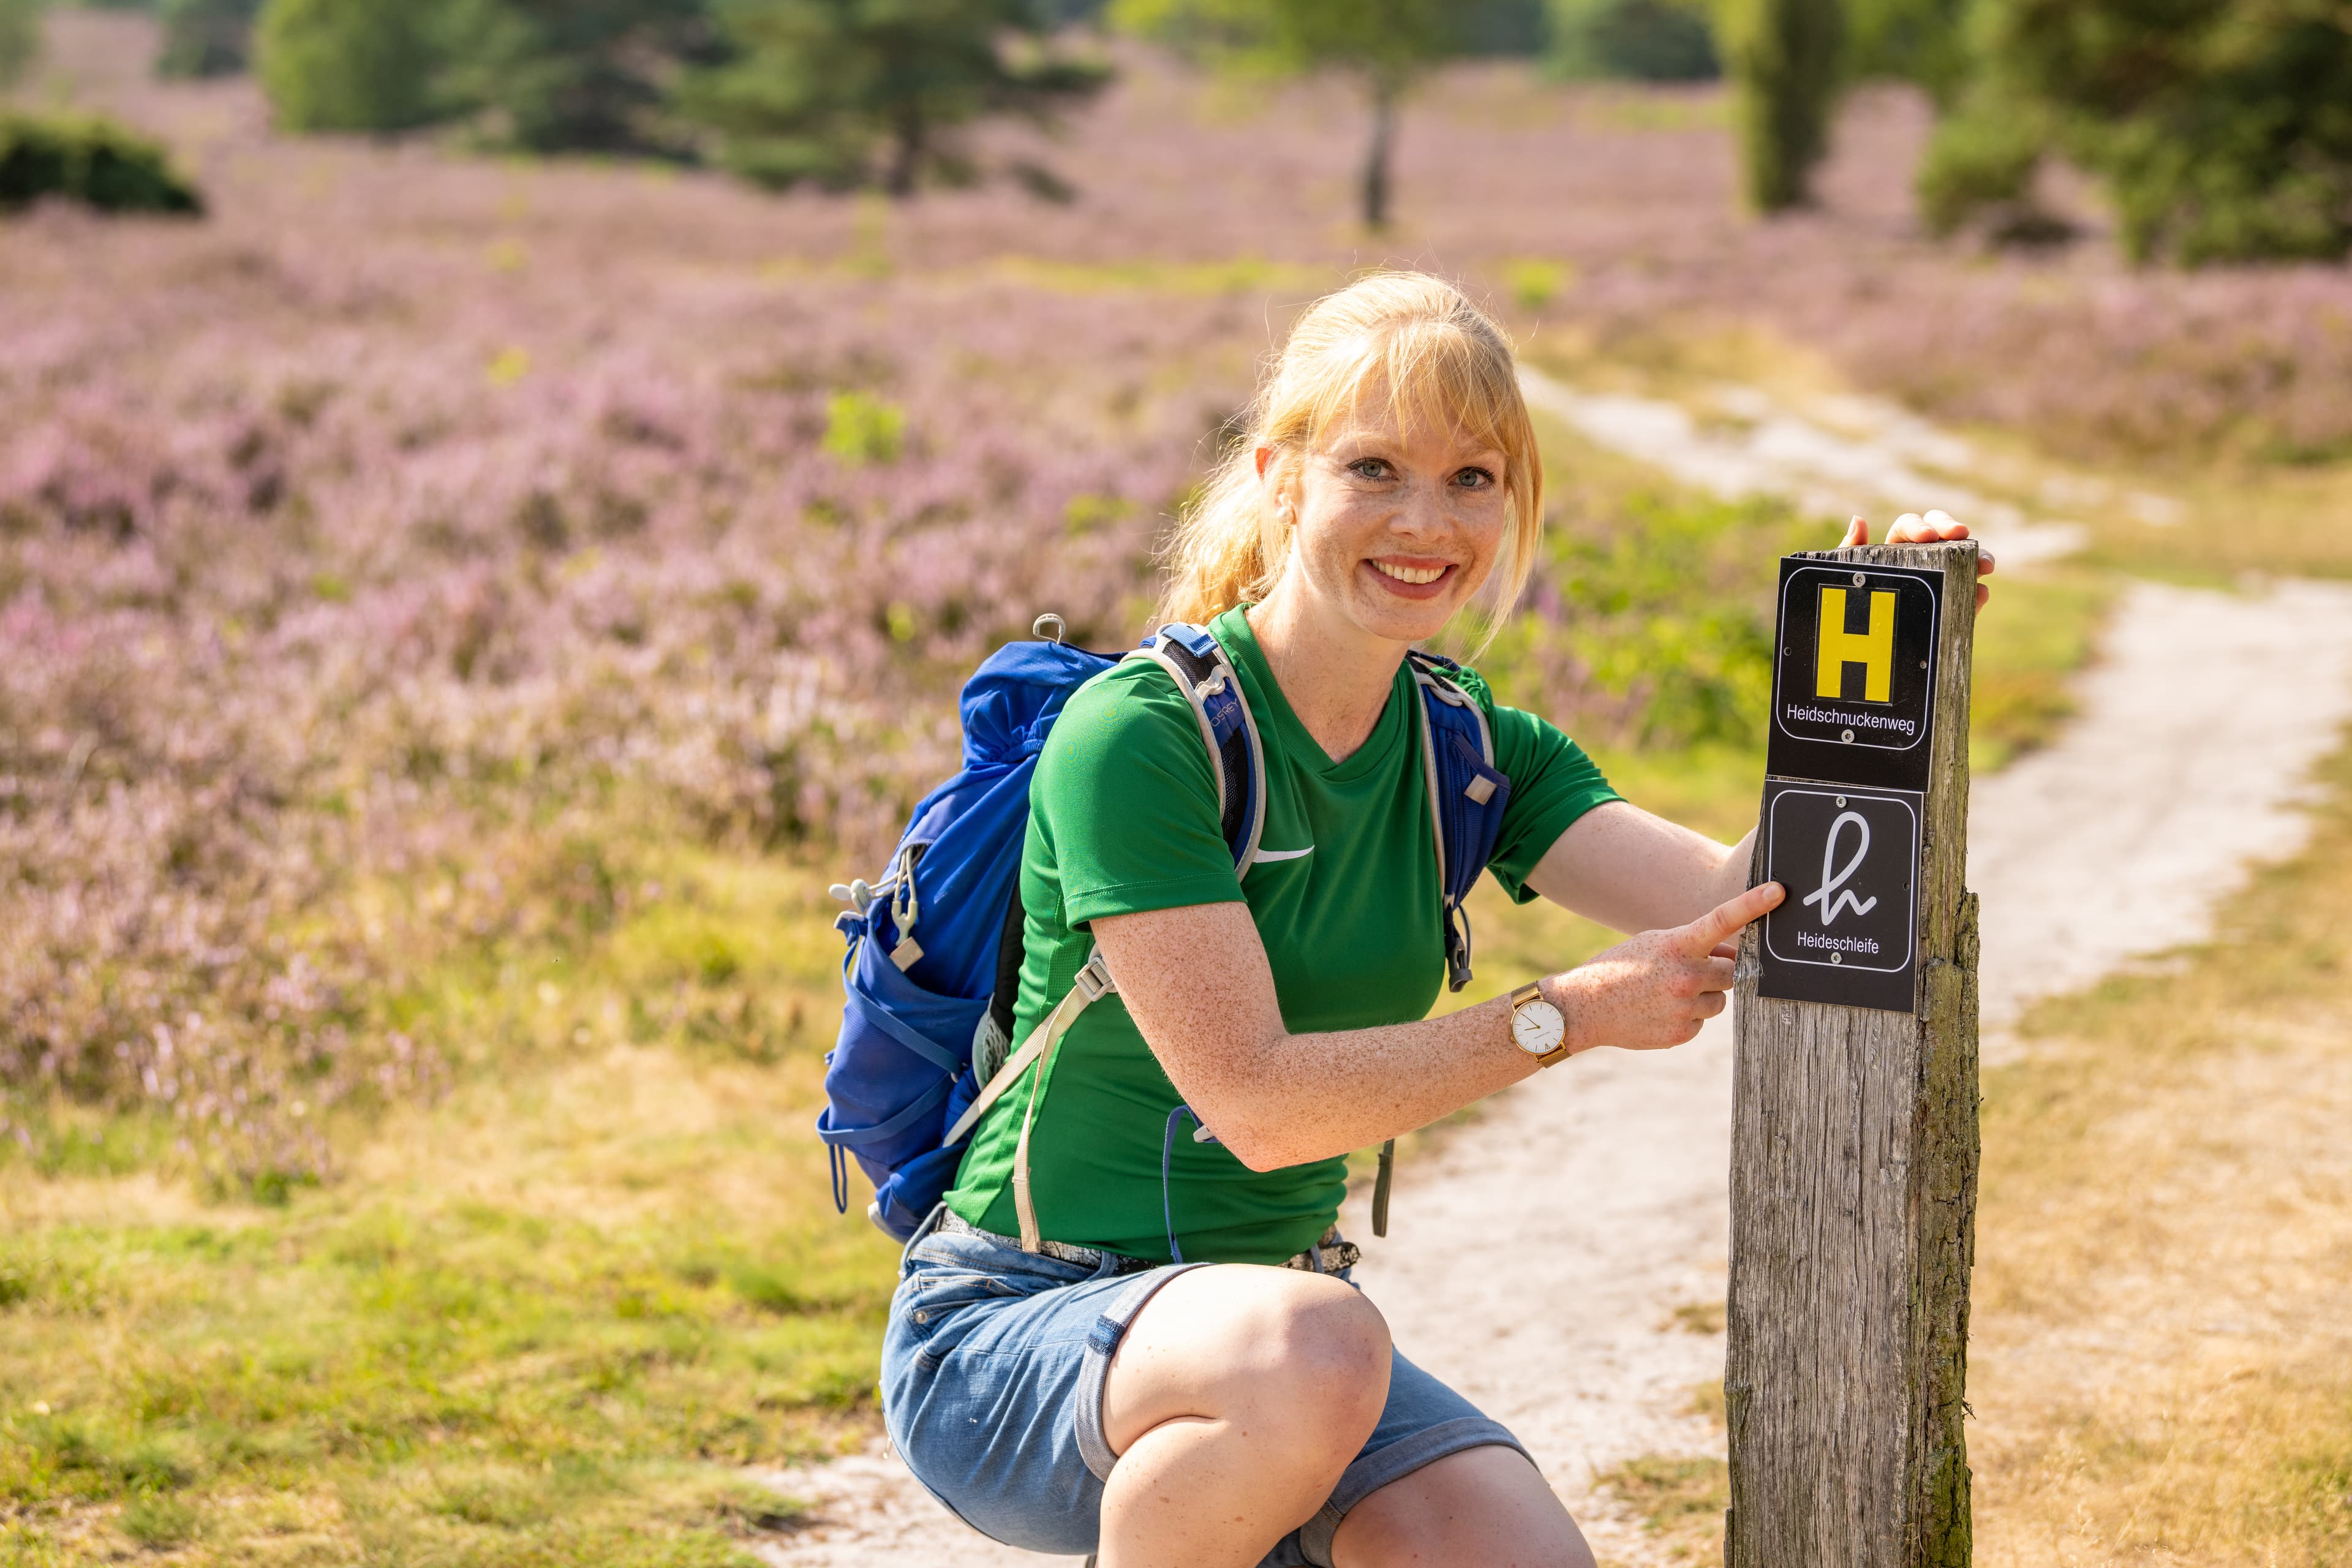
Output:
254,0,447,132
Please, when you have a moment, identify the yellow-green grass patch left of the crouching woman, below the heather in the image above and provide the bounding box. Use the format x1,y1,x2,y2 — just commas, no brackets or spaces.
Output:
0,832,894,1566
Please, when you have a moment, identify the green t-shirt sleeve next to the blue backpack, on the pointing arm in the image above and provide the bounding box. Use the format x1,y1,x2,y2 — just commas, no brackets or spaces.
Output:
1030,665,1242,926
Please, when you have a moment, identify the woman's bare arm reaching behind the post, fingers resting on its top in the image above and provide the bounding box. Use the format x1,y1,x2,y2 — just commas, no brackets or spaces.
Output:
1526,513,1992,931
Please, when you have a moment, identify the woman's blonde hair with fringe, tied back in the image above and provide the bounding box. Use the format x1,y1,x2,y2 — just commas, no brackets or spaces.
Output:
1155,273,1543,649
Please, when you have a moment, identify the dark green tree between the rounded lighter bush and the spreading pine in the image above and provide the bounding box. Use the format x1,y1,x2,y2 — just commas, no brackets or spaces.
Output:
437,0,717,153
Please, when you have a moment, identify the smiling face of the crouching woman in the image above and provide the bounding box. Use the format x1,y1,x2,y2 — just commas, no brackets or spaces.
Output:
1258,398,1510,642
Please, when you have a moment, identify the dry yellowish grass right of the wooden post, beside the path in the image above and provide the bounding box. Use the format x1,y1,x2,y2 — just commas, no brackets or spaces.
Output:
1971,752,2352,1568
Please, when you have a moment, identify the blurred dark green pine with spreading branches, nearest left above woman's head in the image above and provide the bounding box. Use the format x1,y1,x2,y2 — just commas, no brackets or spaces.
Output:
677,0,1110,195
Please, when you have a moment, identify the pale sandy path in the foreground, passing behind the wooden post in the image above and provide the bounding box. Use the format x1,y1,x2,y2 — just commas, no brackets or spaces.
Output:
762,583,2352,1568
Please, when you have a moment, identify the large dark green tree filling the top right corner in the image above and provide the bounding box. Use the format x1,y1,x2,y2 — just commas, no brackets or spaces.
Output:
1919,0,2352,266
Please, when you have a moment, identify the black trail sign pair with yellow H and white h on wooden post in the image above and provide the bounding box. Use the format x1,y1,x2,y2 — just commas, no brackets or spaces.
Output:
1757,557,1943,1013
